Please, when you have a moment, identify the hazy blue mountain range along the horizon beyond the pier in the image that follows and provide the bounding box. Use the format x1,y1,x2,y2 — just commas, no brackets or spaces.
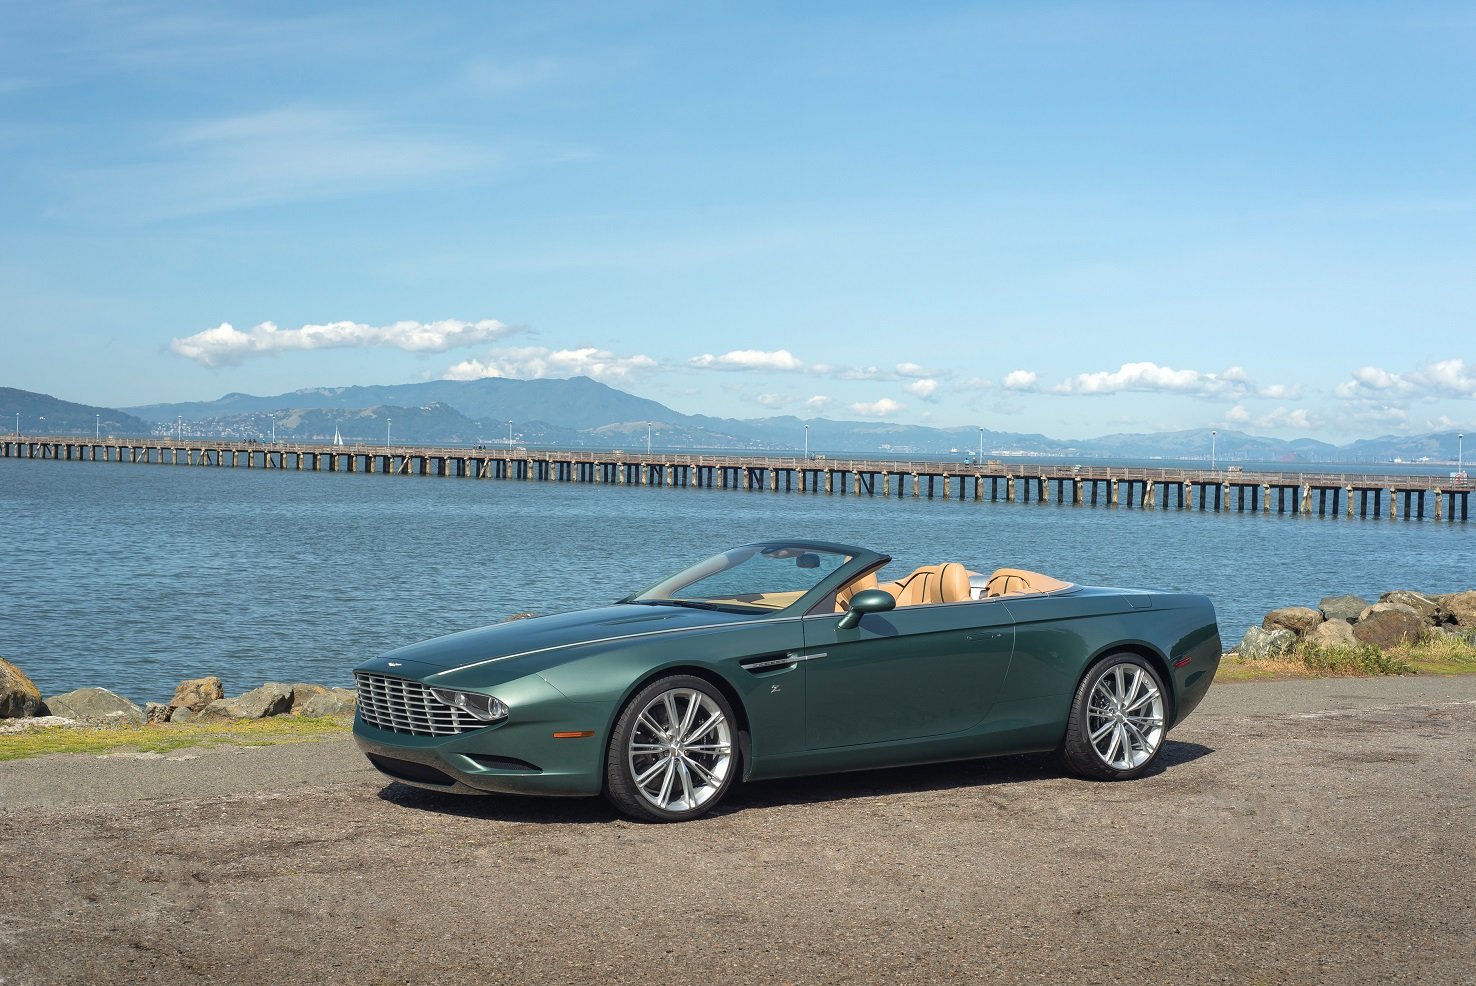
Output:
0,376,1458,463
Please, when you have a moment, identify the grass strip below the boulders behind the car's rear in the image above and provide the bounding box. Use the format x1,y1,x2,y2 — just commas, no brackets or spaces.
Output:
1215,633,1476,682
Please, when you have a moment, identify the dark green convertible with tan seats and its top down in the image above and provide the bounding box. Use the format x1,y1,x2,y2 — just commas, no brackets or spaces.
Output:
354,540,1221,821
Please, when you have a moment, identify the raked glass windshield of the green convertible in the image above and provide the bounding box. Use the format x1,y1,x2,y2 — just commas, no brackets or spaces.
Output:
627,545,852,613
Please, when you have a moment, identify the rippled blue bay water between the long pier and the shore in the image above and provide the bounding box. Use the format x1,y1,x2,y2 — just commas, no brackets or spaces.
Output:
0,459,1476,703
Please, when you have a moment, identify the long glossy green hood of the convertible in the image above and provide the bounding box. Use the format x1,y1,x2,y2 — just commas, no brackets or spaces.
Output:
359,605,763,678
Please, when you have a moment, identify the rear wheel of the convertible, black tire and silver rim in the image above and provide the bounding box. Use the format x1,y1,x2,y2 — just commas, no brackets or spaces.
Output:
1061,654,1168,781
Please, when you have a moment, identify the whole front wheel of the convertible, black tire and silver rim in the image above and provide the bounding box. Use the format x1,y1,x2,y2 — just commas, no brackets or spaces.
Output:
605,675,739,822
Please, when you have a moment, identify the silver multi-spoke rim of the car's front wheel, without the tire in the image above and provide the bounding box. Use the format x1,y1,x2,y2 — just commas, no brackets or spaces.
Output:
626,688,734,815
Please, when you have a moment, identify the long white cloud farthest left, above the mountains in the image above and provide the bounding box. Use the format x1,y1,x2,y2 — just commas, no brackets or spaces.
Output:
170,319,517,366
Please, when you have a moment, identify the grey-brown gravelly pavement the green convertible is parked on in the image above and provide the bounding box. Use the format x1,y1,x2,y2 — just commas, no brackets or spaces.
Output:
0,678,1476,986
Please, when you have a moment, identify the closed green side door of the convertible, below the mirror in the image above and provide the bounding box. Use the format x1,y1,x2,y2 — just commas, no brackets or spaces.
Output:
803,599,1014,750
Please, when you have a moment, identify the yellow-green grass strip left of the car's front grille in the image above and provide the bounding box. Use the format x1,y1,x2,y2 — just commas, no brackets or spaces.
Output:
0,716,350,760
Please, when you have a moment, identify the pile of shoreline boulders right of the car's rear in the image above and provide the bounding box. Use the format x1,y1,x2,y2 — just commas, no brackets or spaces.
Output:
1231,589,1476,661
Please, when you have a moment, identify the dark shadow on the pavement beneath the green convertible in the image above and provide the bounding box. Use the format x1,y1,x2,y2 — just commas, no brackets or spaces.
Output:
371,740,1215,825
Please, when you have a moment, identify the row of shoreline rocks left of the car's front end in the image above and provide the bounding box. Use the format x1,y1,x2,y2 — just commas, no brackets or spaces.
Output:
0,667,357,726
